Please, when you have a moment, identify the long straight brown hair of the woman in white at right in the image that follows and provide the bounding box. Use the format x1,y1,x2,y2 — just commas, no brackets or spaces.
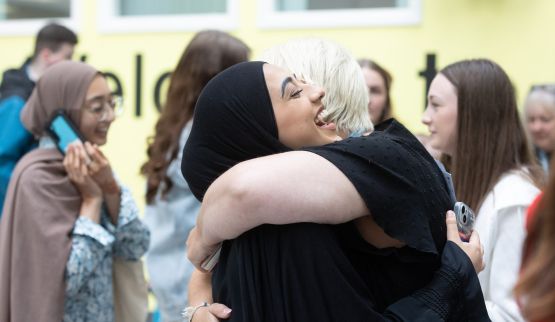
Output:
440,59,541,210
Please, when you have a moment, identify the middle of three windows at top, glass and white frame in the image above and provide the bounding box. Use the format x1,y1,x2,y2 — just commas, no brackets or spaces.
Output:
99,0,238,33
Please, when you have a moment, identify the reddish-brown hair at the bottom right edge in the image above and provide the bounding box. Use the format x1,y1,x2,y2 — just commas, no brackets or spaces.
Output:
515,165,555,321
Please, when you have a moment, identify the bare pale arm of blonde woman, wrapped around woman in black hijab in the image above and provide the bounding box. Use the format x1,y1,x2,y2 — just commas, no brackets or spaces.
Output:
198,152,369,244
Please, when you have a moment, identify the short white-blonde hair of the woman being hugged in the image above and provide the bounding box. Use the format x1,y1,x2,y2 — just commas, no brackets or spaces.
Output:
259,38,374,133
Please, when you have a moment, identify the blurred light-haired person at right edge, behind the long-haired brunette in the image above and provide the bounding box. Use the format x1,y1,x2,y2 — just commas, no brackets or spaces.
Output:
524,84,555,173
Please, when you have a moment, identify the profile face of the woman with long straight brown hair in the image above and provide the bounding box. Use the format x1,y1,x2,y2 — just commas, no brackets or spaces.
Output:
422,74,458,156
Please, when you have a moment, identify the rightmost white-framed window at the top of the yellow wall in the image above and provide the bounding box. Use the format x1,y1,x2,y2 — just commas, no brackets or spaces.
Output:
258,0,421,28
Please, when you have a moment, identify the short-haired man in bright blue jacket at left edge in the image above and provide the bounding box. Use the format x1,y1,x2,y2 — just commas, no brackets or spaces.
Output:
0,23,77,216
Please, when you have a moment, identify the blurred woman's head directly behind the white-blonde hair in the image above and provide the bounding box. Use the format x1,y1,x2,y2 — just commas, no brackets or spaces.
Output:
358,59,393,124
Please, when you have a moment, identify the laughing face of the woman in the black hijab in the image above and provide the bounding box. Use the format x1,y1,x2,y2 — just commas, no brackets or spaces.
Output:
263,64,338,149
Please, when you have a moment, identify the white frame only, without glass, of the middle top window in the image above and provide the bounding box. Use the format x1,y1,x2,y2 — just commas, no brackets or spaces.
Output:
98,0,239,34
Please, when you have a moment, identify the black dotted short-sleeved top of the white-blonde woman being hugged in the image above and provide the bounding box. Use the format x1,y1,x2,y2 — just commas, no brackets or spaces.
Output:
306,119,453,255
